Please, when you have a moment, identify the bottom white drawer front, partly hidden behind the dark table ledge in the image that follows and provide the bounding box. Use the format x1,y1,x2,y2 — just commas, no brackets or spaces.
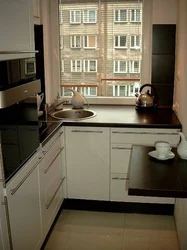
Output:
110,174,175,204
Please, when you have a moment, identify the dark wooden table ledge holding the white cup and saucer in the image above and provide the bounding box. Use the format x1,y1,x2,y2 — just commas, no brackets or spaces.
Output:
128,146,187,198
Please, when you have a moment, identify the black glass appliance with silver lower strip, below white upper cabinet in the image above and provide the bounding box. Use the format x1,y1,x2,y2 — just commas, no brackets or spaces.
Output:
0,57,41,109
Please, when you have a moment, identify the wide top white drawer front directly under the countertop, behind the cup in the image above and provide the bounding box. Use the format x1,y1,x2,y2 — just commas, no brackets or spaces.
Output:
111,128,180,146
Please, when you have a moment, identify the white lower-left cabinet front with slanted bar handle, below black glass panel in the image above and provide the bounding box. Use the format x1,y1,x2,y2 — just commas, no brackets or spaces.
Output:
7,155,42,250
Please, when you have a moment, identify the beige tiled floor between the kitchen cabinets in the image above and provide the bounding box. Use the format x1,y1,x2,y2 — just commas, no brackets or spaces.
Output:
45,210,179,250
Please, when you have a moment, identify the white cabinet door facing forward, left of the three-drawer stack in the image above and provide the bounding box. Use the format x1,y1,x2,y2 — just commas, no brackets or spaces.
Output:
65,127,110,200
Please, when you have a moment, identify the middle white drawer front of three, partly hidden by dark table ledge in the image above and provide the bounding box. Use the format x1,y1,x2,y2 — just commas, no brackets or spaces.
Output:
111,144,132,174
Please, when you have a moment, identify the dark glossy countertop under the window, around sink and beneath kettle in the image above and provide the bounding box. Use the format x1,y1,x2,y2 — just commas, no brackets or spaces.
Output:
40,105,182,129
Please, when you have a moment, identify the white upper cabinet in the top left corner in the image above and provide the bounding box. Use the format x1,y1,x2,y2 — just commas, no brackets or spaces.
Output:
0,0,34,60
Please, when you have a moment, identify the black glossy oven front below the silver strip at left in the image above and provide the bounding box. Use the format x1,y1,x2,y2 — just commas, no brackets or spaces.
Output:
0,101,40,182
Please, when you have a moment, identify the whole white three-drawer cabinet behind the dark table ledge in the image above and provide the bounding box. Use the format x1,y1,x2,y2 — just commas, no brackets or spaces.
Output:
110,128,179,204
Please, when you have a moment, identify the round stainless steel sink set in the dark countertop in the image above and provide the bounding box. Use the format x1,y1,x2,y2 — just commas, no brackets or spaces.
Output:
51,109,96,120
